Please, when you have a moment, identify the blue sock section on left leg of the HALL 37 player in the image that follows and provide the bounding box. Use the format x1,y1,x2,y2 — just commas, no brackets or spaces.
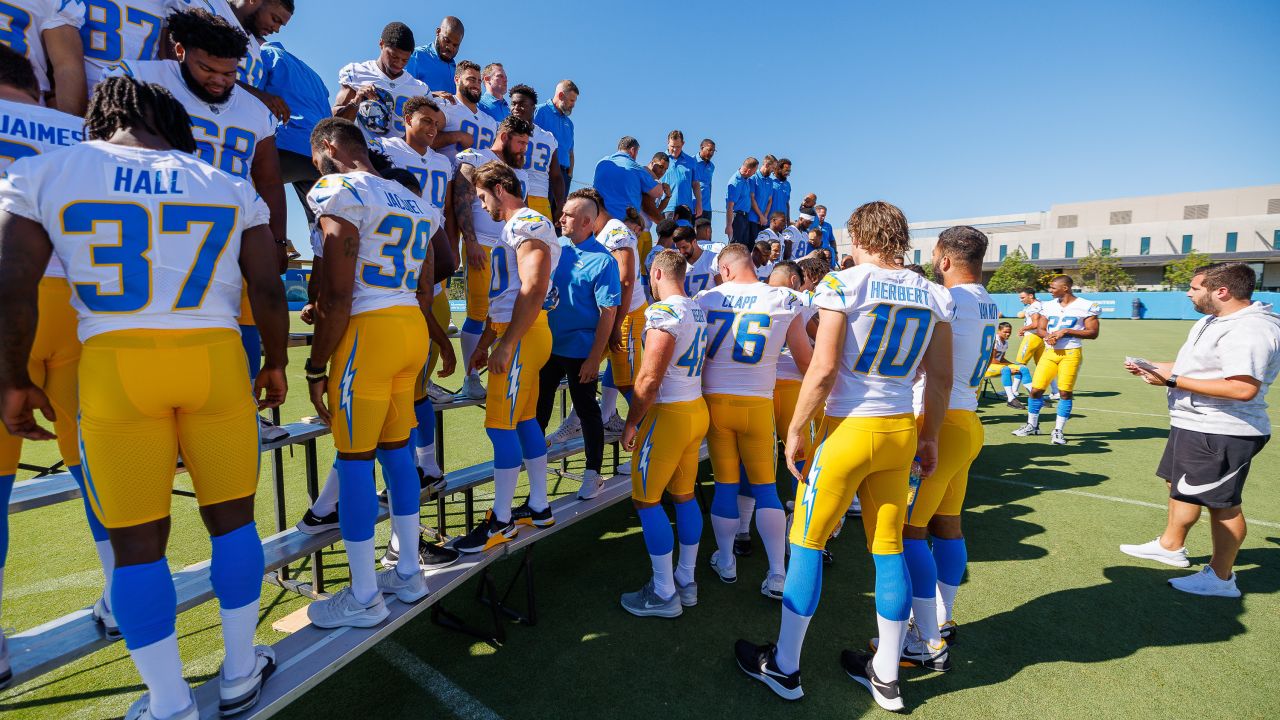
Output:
111,557,177,650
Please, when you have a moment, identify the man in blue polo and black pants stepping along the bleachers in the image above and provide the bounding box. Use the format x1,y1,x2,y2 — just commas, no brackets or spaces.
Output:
538,191,622,500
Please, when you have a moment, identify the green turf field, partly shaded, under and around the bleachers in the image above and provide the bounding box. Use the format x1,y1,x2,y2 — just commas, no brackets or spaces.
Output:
0,318,1280,720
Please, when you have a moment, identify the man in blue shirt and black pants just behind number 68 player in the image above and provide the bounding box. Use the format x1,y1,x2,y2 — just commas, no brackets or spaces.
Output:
262,40,330,224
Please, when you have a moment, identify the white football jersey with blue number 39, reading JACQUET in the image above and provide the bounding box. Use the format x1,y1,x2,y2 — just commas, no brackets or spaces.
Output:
307,172,442,315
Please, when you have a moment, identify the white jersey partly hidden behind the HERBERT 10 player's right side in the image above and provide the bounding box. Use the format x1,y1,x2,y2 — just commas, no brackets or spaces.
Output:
948,283,1000,411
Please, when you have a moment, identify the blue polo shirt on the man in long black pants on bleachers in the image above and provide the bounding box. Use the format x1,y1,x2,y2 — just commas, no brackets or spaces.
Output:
547,237,622,357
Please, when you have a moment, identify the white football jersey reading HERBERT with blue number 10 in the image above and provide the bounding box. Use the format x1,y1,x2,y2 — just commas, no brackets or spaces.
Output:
813,264,959,418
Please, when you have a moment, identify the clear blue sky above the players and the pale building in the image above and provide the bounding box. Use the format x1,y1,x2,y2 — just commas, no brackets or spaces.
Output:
276,0,1280,247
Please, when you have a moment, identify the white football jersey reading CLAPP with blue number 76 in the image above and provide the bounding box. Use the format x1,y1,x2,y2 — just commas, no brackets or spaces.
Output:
695,283,804,397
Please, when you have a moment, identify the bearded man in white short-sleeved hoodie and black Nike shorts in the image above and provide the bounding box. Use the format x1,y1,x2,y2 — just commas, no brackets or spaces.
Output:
1120,263,1280,597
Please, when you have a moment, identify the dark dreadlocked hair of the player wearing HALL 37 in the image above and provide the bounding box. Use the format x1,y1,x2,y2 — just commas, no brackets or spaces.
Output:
84,77,196,152
